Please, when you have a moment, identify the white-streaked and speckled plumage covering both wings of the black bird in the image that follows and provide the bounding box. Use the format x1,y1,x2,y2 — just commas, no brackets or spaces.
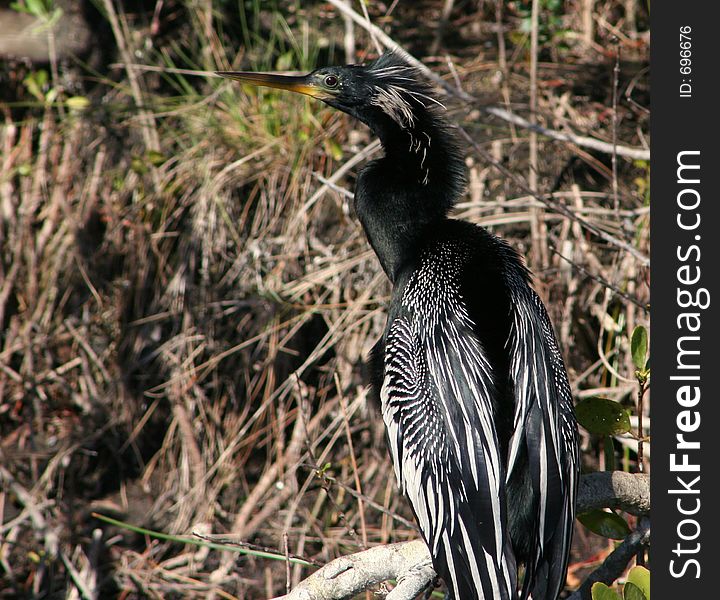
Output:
380,234,578,600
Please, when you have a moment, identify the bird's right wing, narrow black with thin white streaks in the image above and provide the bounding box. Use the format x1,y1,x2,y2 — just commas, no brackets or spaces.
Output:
507,276,579,600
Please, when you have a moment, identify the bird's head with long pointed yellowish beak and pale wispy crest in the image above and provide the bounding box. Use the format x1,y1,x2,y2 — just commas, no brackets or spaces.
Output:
217,52,442,136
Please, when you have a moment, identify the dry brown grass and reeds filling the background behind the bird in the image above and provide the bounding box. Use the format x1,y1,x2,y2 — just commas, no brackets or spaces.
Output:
0,1,649,598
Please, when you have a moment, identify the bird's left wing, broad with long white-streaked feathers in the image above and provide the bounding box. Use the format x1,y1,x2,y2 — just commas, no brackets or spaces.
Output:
380,310,517,600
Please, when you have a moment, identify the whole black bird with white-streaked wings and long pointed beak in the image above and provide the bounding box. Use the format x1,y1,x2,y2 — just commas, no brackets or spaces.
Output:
219,52,579,600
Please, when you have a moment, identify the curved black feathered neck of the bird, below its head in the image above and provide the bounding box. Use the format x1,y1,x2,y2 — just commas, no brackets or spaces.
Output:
355,110,465,281
